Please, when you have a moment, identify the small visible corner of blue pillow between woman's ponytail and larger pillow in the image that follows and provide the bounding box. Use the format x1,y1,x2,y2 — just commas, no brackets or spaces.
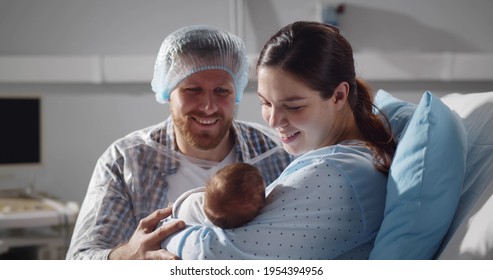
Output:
374,90,417,141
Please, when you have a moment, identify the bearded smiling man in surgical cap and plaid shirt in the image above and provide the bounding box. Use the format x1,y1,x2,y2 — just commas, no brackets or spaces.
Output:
67,26,292,259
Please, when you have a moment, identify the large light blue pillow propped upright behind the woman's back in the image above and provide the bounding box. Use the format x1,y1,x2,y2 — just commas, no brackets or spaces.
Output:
370,92,466,259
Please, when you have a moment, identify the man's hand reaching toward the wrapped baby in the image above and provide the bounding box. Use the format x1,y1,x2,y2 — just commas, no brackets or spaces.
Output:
108,207,185,260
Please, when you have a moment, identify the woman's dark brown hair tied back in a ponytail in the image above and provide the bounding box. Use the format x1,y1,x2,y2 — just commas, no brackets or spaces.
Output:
257,21,396,173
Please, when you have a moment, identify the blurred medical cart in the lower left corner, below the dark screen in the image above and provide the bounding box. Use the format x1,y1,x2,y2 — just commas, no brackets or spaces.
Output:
0,188,79,259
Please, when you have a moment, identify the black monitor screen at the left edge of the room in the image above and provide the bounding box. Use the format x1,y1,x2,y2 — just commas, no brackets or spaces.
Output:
0,97,41,165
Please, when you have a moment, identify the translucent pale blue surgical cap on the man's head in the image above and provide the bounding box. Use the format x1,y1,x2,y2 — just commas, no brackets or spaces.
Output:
151,25,248,104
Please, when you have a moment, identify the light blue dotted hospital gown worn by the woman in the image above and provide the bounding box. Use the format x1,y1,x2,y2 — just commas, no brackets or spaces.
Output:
161,142,387,260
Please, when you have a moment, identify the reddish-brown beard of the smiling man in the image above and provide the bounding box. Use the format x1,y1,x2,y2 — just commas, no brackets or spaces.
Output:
173,114,233,150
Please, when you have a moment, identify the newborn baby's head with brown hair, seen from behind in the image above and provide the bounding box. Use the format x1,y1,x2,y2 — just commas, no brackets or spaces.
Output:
204,163,265,228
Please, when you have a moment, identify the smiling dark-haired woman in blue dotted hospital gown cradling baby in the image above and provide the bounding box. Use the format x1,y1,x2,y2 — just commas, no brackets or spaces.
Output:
162,22,395,259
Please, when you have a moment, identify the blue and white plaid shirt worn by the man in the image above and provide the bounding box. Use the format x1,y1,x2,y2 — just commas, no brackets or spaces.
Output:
67,117,293,259
